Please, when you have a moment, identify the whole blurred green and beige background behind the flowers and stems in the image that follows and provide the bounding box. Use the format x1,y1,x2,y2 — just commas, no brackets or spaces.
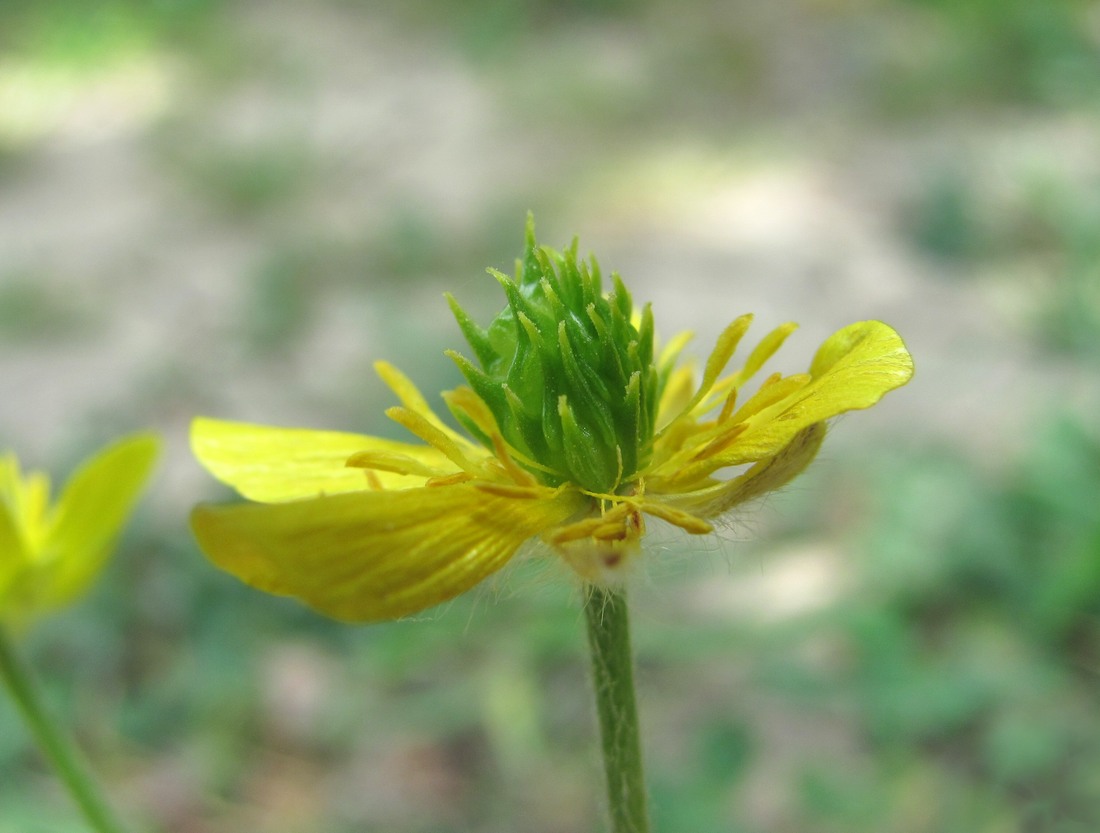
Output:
0,0,1100,833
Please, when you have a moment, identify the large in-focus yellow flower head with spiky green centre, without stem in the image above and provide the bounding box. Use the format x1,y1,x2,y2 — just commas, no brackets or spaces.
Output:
191,217,913,621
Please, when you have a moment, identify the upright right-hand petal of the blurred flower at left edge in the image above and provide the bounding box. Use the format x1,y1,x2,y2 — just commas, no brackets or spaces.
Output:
34,434,161,607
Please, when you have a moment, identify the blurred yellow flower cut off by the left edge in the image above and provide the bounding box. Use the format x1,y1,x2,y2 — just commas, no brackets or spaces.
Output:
0,434,160,626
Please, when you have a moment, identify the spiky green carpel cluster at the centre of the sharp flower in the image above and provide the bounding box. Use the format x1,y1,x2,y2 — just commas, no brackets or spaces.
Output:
448,218,659,493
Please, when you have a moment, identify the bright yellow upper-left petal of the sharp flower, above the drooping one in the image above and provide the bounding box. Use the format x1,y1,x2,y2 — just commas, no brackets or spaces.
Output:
191,417,457,502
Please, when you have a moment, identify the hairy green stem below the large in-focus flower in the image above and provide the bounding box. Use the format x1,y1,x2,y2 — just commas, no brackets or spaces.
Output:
584,584,649,833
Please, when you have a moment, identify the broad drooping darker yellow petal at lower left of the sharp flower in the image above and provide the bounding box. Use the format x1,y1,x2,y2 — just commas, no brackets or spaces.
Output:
191,483,580,622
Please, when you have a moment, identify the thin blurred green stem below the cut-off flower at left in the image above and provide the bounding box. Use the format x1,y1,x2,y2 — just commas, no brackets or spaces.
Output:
0,628,125,833
